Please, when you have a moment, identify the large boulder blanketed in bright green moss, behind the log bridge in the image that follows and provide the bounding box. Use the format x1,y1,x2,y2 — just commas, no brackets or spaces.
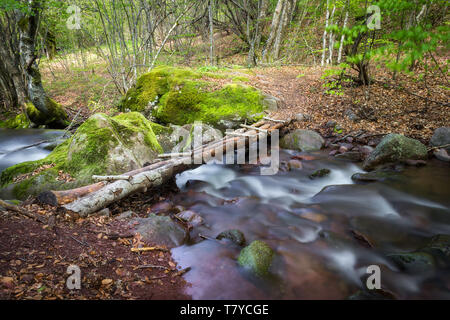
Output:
120,67,265,129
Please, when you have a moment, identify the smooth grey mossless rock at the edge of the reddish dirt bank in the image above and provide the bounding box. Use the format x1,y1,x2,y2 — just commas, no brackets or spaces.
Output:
136,214,188,247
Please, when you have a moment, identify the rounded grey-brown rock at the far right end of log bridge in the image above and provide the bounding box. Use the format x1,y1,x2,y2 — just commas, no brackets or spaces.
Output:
280,129,325,152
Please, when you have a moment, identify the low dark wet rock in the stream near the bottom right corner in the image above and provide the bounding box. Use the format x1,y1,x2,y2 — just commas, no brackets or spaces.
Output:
388,252,435,273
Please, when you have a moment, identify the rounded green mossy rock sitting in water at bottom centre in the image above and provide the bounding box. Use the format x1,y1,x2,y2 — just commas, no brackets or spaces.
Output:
238,240,274,276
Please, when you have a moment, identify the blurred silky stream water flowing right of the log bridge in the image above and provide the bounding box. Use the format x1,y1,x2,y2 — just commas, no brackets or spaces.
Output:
172,151,450,299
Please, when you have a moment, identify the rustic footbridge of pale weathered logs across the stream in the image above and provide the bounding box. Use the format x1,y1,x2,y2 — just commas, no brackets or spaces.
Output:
37,117,292,217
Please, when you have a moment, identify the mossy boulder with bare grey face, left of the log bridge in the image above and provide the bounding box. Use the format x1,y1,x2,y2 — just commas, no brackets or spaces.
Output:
0,112,163,199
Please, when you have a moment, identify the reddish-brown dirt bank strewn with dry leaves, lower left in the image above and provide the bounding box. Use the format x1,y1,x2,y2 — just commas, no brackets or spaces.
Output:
0,185,190,300
